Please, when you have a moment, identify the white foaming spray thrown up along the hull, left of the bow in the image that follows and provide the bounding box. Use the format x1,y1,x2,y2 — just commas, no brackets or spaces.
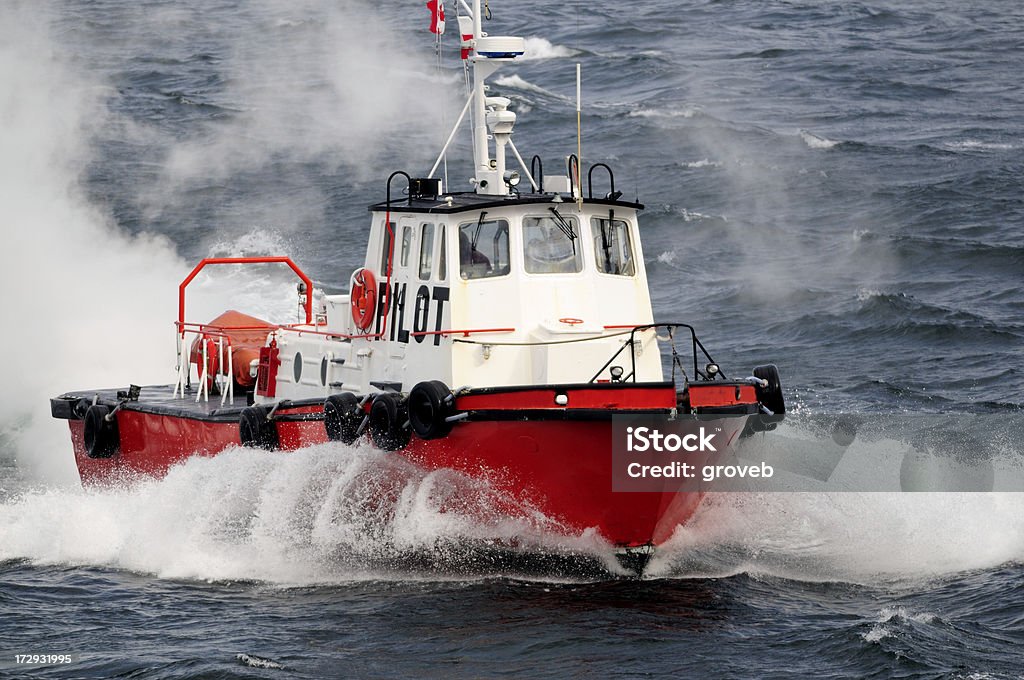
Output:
0,443,611,584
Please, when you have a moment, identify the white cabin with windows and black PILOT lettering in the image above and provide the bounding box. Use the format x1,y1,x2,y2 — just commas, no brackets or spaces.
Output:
257,188,663,401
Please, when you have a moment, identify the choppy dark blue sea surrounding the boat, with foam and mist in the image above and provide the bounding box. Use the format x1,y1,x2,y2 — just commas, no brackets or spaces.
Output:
0,0,1024,678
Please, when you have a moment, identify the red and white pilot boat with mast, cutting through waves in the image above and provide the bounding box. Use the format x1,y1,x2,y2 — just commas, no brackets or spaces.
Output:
51,0,785,566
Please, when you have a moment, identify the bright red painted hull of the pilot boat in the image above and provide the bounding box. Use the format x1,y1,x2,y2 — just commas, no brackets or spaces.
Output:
58,385,751,547
